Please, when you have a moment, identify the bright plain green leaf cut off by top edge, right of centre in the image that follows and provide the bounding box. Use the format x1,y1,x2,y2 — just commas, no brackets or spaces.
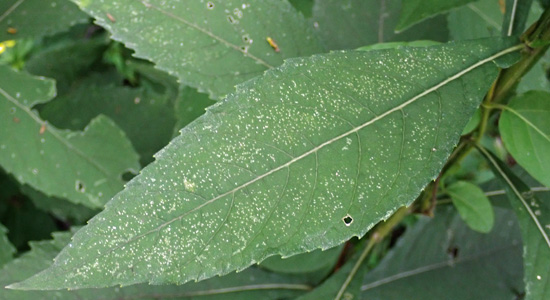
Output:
395,0,475,32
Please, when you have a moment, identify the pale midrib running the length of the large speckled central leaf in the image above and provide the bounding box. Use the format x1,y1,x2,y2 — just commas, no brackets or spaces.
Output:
88,44,523,264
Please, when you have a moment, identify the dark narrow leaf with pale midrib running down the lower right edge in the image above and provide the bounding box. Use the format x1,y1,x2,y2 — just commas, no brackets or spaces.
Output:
479,148,550,300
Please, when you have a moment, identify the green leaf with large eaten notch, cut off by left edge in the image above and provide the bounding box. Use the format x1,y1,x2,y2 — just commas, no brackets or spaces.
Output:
0,66,139,208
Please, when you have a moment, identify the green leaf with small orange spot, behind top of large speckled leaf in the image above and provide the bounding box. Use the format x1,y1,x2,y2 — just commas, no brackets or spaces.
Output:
73,0,324,99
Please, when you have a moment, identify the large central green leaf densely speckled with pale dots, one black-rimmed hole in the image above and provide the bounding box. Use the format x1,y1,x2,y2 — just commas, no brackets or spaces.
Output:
14,39,519,289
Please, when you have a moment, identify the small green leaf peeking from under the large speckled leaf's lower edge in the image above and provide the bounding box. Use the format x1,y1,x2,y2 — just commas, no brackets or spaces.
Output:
260,246,342,273
